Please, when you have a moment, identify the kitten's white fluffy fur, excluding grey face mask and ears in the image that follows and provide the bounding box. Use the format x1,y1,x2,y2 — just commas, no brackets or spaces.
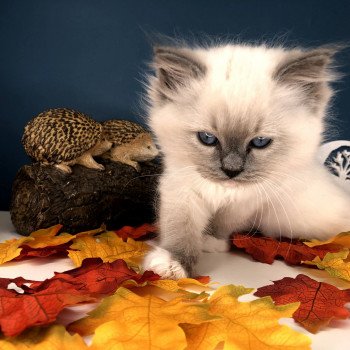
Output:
145,45,350,278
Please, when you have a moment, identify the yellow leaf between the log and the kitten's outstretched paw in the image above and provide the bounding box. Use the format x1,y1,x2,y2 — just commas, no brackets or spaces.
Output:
68,231,148,266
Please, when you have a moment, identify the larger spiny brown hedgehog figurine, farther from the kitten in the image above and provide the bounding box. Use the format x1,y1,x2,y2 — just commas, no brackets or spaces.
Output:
22,108,112,173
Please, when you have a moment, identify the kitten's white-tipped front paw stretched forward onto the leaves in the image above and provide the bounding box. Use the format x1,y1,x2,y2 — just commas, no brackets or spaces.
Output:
143,247,187,280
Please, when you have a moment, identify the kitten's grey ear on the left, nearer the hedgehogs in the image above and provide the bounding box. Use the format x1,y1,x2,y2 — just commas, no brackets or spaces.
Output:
153,47,206,100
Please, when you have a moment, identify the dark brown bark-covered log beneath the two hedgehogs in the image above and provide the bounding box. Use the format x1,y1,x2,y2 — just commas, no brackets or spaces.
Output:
10,159,161,236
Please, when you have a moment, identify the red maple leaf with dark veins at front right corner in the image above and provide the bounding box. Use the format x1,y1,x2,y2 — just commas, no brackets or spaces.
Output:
254,274,350,333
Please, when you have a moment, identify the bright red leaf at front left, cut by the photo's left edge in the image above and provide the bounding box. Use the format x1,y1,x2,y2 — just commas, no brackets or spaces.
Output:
0,280,95,336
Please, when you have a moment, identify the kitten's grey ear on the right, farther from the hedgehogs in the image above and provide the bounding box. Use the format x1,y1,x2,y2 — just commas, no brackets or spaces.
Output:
274,46,342,108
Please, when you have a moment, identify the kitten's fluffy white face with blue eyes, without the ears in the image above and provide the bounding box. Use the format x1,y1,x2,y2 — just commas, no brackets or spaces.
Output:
150,47,336,184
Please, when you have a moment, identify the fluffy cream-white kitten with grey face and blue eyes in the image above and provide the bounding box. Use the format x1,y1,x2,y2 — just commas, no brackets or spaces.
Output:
145,45,350,278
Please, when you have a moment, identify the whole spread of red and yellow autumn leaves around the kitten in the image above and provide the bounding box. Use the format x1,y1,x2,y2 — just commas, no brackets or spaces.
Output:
0,225,350,350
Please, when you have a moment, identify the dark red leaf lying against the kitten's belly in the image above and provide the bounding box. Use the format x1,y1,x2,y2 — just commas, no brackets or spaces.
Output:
232,233,339,265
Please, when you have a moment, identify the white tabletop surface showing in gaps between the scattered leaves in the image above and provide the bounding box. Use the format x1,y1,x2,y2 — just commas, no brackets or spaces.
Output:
0,212,350,350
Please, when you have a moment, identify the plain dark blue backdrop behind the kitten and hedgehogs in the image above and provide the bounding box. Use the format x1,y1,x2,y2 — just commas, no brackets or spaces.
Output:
0,0,350,210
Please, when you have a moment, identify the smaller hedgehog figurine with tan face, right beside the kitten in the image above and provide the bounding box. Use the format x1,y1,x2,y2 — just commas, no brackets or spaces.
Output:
102,119,159,171
